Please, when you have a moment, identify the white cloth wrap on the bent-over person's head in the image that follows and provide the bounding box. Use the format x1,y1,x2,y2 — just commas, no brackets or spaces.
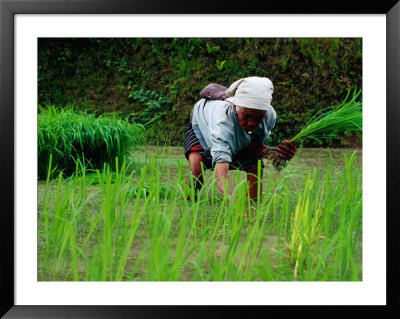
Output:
225,76,274,111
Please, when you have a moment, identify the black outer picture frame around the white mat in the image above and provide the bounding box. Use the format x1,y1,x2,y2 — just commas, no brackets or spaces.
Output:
0,0,400,318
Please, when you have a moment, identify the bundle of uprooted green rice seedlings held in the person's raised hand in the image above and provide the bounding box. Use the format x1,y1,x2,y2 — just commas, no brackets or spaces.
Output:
267,90,362,170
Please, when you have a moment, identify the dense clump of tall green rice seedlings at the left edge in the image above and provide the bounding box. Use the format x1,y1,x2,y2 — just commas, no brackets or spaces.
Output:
38,105,145,179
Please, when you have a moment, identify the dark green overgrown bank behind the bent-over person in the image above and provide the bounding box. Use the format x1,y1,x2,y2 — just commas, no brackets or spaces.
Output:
38,38,362,146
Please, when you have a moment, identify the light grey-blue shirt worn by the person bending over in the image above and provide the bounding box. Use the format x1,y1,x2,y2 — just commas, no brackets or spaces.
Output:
192,98,276,166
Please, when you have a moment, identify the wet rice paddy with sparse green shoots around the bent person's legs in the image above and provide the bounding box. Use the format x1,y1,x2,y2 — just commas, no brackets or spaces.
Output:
38,146,362,281
